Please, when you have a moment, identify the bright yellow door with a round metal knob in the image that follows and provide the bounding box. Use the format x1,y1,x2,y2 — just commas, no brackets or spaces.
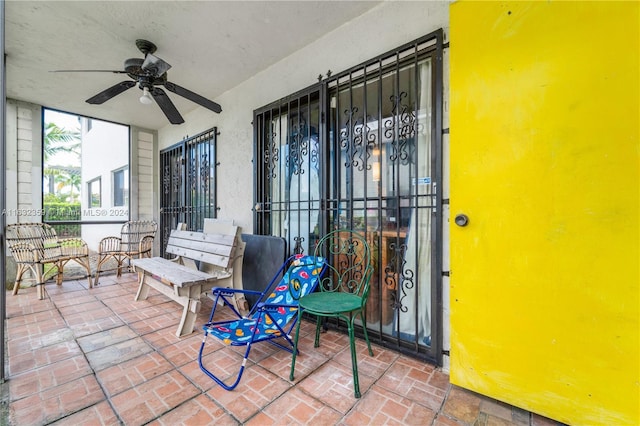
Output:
449,1,640,425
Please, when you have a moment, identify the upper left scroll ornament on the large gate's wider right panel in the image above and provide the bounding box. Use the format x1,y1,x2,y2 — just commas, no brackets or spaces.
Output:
340,107,377,171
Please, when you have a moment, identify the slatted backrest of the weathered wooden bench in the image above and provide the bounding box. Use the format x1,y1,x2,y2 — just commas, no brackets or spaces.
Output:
166,230,236,268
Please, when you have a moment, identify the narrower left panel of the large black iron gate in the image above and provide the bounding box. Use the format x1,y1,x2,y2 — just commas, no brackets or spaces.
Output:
254,85,322,253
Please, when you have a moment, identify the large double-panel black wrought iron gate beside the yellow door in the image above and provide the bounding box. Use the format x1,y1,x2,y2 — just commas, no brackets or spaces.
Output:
254,31,443,362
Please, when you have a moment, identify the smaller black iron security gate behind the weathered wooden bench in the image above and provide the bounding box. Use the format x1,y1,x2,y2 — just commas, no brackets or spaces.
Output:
160,127,218,256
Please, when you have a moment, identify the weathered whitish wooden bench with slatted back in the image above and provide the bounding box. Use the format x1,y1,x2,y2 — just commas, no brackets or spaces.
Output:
132,225,244,337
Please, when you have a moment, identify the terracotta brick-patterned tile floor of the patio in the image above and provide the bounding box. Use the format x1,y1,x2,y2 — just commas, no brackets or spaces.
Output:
0,274,556,426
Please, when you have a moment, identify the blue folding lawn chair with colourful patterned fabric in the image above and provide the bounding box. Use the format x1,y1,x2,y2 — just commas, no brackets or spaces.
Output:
198,255,325,390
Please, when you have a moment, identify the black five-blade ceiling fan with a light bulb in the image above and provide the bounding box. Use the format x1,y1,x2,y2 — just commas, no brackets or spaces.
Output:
54,39,222,124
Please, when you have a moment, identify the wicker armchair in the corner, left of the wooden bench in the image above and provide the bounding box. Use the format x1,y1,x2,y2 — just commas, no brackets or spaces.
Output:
95,220,158,285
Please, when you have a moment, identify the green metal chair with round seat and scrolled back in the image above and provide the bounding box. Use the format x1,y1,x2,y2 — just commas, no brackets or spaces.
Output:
289,229,373,398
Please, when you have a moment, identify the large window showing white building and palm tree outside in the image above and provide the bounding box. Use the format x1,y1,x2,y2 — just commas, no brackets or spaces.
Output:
42,108,129,250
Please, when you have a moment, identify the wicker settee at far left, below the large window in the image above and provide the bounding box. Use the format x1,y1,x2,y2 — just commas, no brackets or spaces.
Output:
5,223,93,300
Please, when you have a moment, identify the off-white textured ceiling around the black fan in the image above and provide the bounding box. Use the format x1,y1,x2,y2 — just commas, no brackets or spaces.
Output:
5,0,379,129
